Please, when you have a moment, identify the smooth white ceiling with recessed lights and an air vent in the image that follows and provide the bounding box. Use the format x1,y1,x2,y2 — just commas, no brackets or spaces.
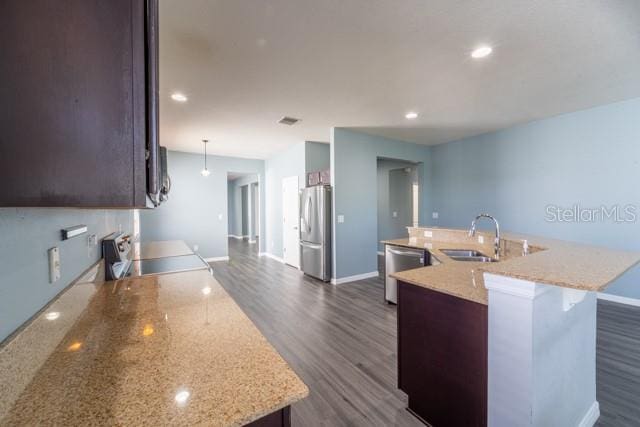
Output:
160,0,640,158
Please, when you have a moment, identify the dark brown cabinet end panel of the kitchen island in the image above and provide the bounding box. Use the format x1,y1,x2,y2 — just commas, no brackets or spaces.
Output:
398,282,487,427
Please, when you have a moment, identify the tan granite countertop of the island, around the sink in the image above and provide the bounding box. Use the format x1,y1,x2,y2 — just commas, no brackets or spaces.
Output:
382,227,640,305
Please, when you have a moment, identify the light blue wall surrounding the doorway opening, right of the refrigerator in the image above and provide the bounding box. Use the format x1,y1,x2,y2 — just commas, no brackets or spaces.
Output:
331,128,431,278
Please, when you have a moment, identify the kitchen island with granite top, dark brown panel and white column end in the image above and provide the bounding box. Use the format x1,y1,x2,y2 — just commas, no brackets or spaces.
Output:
384,227,640,426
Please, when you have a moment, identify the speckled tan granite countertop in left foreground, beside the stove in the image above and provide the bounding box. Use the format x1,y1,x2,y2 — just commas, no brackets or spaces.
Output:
0,271,309,426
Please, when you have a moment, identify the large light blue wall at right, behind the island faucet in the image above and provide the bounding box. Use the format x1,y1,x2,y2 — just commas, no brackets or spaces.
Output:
432,99,640,298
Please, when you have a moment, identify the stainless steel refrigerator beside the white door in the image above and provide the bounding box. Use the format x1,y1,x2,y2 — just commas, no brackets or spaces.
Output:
300,185,331,282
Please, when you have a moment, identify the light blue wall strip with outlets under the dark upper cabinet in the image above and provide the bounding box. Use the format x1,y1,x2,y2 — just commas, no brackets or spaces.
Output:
0,208,133,341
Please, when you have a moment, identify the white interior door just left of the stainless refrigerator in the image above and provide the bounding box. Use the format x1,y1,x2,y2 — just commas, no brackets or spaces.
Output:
282,176,300,268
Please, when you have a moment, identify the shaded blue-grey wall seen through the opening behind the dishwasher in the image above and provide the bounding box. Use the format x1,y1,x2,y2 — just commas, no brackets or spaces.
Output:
376,160,418,251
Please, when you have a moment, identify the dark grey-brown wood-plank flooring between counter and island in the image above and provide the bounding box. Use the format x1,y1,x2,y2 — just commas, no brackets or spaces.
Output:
212,239,640,426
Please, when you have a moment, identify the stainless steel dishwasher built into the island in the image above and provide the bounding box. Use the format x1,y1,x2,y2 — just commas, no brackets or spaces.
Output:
384,245,430,304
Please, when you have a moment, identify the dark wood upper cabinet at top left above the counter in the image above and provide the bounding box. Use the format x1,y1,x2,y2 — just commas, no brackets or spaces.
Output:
0,0,158,208
